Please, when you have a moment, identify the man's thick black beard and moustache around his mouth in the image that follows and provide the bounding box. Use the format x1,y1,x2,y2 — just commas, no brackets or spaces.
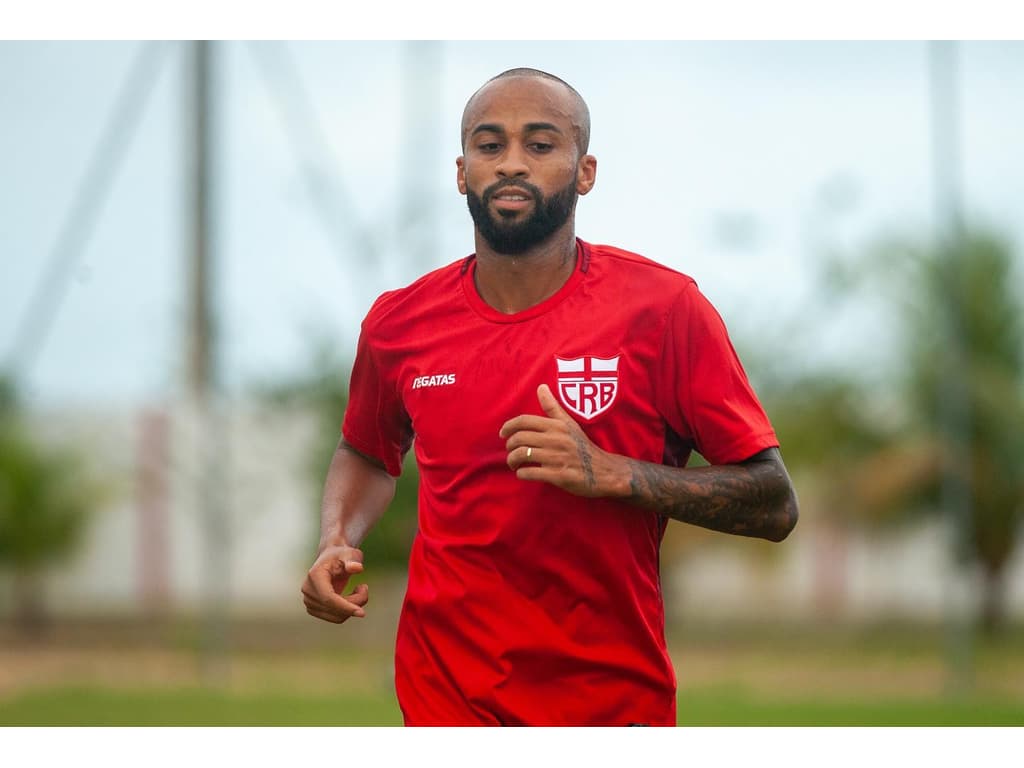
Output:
466,179,577,256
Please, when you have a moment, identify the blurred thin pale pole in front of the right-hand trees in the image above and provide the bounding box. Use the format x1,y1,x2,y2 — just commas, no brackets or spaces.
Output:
928,41,974,694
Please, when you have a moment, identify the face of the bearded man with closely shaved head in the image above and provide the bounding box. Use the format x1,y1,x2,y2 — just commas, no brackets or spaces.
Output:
457,78,596,255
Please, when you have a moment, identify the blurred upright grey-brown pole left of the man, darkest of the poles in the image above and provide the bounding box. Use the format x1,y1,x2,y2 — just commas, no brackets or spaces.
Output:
185,40,230,682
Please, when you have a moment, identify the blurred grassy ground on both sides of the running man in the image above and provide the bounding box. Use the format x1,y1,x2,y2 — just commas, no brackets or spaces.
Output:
0,625,1024,727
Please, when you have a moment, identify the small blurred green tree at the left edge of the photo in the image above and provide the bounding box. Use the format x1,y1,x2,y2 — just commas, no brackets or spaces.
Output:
0,379,100,632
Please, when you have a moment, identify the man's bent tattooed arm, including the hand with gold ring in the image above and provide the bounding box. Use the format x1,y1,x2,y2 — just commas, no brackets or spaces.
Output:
500,384,799,542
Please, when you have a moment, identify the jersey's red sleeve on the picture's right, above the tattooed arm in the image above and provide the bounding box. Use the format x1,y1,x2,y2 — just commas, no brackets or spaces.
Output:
655,283,778,464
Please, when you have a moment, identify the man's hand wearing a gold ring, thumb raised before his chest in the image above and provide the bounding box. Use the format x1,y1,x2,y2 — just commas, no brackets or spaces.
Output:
499,384,630,498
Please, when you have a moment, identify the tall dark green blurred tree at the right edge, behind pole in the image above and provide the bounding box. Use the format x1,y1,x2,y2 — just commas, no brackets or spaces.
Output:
893,233,1024,630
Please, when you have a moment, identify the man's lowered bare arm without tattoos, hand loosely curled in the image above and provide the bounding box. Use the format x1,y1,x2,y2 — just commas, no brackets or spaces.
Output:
302,438,395,624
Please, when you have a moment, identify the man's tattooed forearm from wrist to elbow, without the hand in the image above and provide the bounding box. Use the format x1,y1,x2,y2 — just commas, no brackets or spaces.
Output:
630,460,797,541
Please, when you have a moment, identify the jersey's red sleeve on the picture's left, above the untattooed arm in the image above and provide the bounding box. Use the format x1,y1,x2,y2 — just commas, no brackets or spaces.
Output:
341,313,413,477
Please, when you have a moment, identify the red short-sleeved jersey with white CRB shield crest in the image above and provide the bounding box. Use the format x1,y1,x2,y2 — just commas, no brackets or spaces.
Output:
343,241,778,725
